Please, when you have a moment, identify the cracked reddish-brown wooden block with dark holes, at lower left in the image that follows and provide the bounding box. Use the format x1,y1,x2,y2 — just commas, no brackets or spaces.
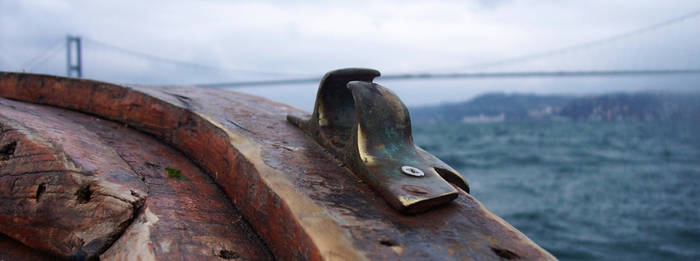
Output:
0,99,148,259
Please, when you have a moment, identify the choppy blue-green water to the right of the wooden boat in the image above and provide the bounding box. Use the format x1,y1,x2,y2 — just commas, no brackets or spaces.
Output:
414,122,700,260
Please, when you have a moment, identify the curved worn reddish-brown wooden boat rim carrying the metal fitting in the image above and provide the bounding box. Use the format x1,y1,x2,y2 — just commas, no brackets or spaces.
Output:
0,73,554,260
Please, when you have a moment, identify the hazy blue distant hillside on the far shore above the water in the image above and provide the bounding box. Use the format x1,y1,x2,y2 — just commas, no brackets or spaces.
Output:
411,92,700,122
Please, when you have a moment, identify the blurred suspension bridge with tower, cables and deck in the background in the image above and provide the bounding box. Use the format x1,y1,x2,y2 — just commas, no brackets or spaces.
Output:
10,10,700,88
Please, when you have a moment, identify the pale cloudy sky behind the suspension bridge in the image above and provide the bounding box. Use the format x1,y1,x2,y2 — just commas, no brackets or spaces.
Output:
0,0,700,110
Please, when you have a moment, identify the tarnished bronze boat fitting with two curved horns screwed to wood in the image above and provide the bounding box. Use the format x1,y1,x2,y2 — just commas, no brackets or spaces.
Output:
287,68,469,213
